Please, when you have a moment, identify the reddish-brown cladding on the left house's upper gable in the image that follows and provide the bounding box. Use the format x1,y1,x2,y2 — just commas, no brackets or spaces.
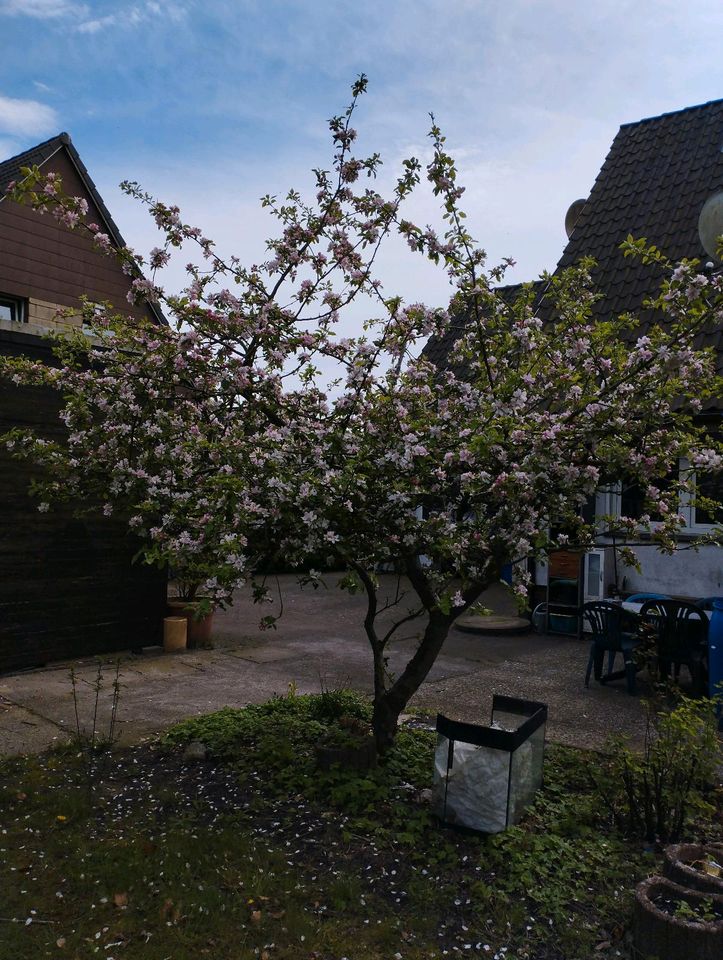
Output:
0,149,151,326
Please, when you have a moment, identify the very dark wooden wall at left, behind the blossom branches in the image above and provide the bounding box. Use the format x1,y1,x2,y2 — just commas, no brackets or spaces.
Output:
0,331,166,670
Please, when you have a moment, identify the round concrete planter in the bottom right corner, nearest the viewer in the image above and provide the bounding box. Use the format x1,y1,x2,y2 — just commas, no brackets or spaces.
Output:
633,877,723,960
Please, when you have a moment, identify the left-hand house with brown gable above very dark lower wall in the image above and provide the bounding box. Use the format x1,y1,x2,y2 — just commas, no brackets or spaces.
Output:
0,133,166,671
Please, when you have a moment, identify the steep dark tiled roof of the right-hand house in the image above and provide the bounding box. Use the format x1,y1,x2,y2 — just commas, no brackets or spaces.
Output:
430,100,723,408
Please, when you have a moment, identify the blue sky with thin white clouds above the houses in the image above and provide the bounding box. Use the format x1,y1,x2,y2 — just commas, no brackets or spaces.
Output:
0,0,723,308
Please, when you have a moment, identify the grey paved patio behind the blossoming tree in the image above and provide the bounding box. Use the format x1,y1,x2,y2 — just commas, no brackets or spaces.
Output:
0,575,664,755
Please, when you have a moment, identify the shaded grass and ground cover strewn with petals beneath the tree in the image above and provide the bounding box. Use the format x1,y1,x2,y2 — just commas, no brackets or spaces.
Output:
0,691,712,960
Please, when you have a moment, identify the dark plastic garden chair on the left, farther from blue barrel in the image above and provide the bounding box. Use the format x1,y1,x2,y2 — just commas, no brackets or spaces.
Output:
582,600,640,694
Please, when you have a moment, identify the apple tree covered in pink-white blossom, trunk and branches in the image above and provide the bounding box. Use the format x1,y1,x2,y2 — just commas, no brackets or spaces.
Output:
5,78,723,752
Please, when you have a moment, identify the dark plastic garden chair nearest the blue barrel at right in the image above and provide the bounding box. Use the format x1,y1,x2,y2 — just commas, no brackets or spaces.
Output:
640,600,708,696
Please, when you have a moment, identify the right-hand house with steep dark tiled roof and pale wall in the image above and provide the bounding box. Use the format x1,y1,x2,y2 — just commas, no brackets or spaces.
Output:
426,100,723,605
